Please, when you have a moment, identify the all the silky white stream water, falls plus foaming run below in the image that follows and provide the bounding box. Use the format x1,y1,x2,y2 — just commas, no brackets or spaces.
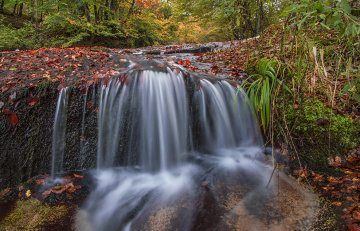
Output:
52,62,316,231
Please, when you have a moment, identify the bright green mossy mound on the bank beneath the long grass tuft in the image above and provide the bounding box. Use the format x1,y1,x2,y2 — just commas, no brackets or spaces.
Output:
278,98,360,174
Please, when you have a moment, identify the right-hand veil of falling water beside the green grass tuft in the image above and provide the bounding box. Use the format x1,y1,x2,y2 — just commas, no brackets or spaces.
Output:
194,79,262,153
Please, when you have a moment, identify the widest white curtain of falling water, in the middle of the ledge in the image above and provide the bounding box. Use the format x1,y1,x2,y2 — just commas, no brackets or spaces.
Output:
97,70,188,171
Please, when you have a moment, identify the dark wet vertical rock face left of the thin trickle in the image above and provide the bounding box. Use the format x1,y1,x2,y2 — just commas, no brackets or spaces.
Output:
0,84,57,188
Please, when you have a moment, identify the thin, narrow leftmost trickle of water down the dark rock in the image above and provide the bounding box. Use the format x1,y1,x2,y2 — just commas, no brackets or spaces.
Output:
51,88,68,179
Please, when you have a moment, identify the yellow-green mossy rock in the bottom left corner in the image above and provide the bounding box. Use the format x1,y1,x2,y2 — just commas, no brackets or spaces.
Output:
0,198,68,230
